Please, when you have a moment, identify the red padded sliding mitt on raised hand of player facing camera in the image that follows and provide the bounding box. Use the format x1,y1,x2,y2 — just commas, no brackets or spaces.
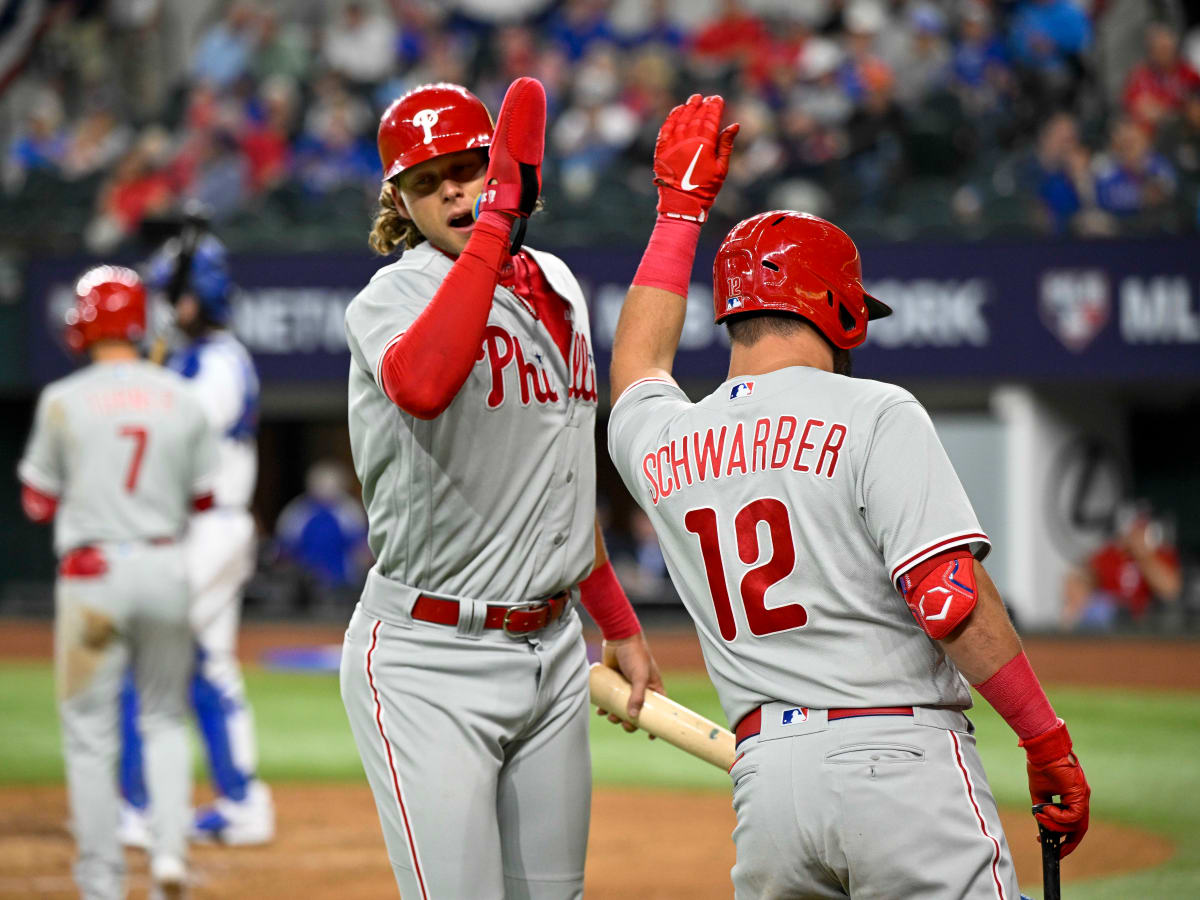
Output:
475,78,546,218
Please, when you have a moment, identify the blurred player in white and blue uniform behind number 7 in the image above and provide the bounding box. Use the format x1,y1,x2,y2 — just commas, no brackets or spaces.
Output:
121,235,275,845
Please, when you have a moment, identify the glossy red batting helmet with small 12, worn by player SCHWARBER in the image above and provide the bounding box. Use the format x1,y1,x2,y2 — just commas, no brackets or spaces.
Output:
713,210,892,350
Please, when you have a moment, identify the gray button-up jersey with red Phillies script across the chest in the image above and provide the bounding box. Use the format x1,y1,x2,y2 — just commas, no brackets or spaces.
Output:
346,244,596,604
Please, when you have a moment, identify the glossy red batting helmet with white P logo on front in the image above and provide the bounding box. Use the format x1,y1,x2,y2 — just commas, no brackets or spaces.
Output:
379,82,492,181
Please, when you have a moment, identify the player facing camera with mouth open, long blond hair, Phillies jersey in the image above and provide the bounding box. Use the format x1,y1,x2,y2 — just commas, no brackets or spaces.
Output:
341,78,661,900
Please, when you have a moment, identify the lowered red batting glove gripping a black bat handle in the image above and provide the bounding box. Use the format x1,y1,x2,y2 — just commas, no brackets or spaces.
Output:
1020,719,1092,859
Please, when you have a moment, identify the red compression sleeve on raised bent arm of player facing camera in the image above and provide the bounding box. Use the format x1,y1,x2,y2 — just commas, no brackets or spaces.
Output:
379,212,511,419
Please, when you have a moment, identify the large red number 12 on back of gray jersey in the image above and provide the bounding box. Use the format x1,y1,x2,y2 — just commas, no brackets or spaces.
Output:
683,497,809,641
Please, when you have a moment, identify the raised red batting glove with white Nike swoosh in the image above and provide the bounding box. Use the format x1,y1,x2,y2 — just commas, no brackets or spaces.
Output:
654,94,739,222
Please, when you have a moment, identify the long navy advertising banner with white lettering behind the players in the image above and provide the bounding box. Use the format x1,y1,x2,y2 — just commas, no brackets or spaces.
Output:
26,239,1200,385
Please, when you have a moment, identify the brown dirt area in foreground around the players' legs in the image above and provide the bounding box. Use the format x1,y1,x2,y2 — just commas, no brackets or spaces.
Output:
0,785,1171,900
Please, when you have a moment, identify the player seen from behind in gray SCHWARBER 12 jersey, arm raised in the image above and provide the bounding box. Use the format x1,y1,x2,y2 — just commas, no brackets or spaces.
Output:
608,96,1090,900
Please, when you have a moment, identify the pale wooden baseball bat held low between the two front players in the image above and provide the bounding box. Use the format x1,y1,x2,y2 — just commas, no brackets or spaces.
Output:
588,662,734,772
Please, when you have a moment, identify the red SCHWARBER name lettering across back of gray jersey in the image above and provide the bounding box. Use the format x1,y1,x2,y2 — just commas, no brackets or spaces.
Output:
642,415,846,505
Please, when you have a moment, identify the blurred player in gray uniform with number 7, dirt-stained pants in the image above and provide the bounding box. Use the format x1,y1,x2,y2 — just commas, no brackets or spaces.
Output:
18,265,216,900
